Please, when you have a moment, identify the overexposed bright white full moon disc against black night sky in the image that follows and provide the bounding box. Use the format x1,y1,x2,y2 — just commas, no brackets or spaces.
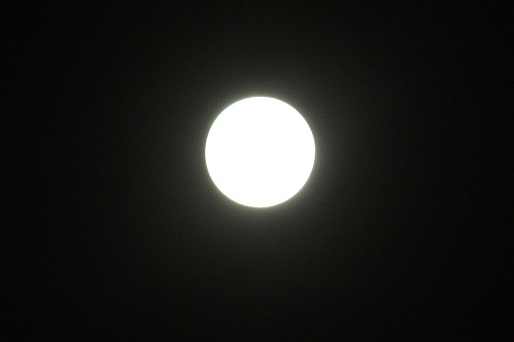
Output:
205,97,315,208
